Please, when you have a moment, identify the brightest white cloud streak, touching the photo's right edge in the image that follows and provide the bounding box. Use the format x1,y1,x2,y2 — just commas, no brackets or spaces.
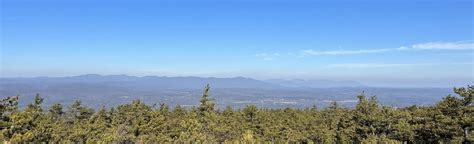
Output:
412,41,474,50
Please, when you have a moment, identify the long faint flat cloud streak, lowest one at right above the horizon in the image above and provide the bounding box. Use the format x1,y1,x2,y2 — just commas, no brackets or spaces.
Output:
328,62,474,68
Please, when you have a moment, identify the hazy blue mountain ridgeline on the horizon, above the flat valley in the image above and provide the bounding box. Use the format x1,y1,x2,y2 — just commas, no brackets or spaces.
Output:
0,74,364,89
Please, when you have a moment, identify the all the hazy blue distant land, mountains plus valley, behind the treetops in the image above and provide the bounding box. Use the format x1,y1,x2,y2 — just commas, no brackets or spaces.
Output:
0,74,452,108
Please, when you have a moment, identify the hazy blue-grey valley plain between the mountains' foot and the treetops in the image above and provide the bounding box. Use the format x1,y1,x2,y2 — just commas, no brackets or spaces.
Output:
0,88,452,108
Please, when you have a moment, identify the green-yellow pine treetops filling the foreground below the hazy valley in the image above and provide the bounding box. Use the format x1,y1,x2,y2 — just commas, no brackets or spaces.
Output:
0,85,474,143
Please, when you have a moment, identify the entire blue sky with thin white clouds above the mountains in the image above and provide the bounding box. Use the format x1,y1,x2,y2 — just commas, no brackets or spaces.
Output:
0,0,474,87
